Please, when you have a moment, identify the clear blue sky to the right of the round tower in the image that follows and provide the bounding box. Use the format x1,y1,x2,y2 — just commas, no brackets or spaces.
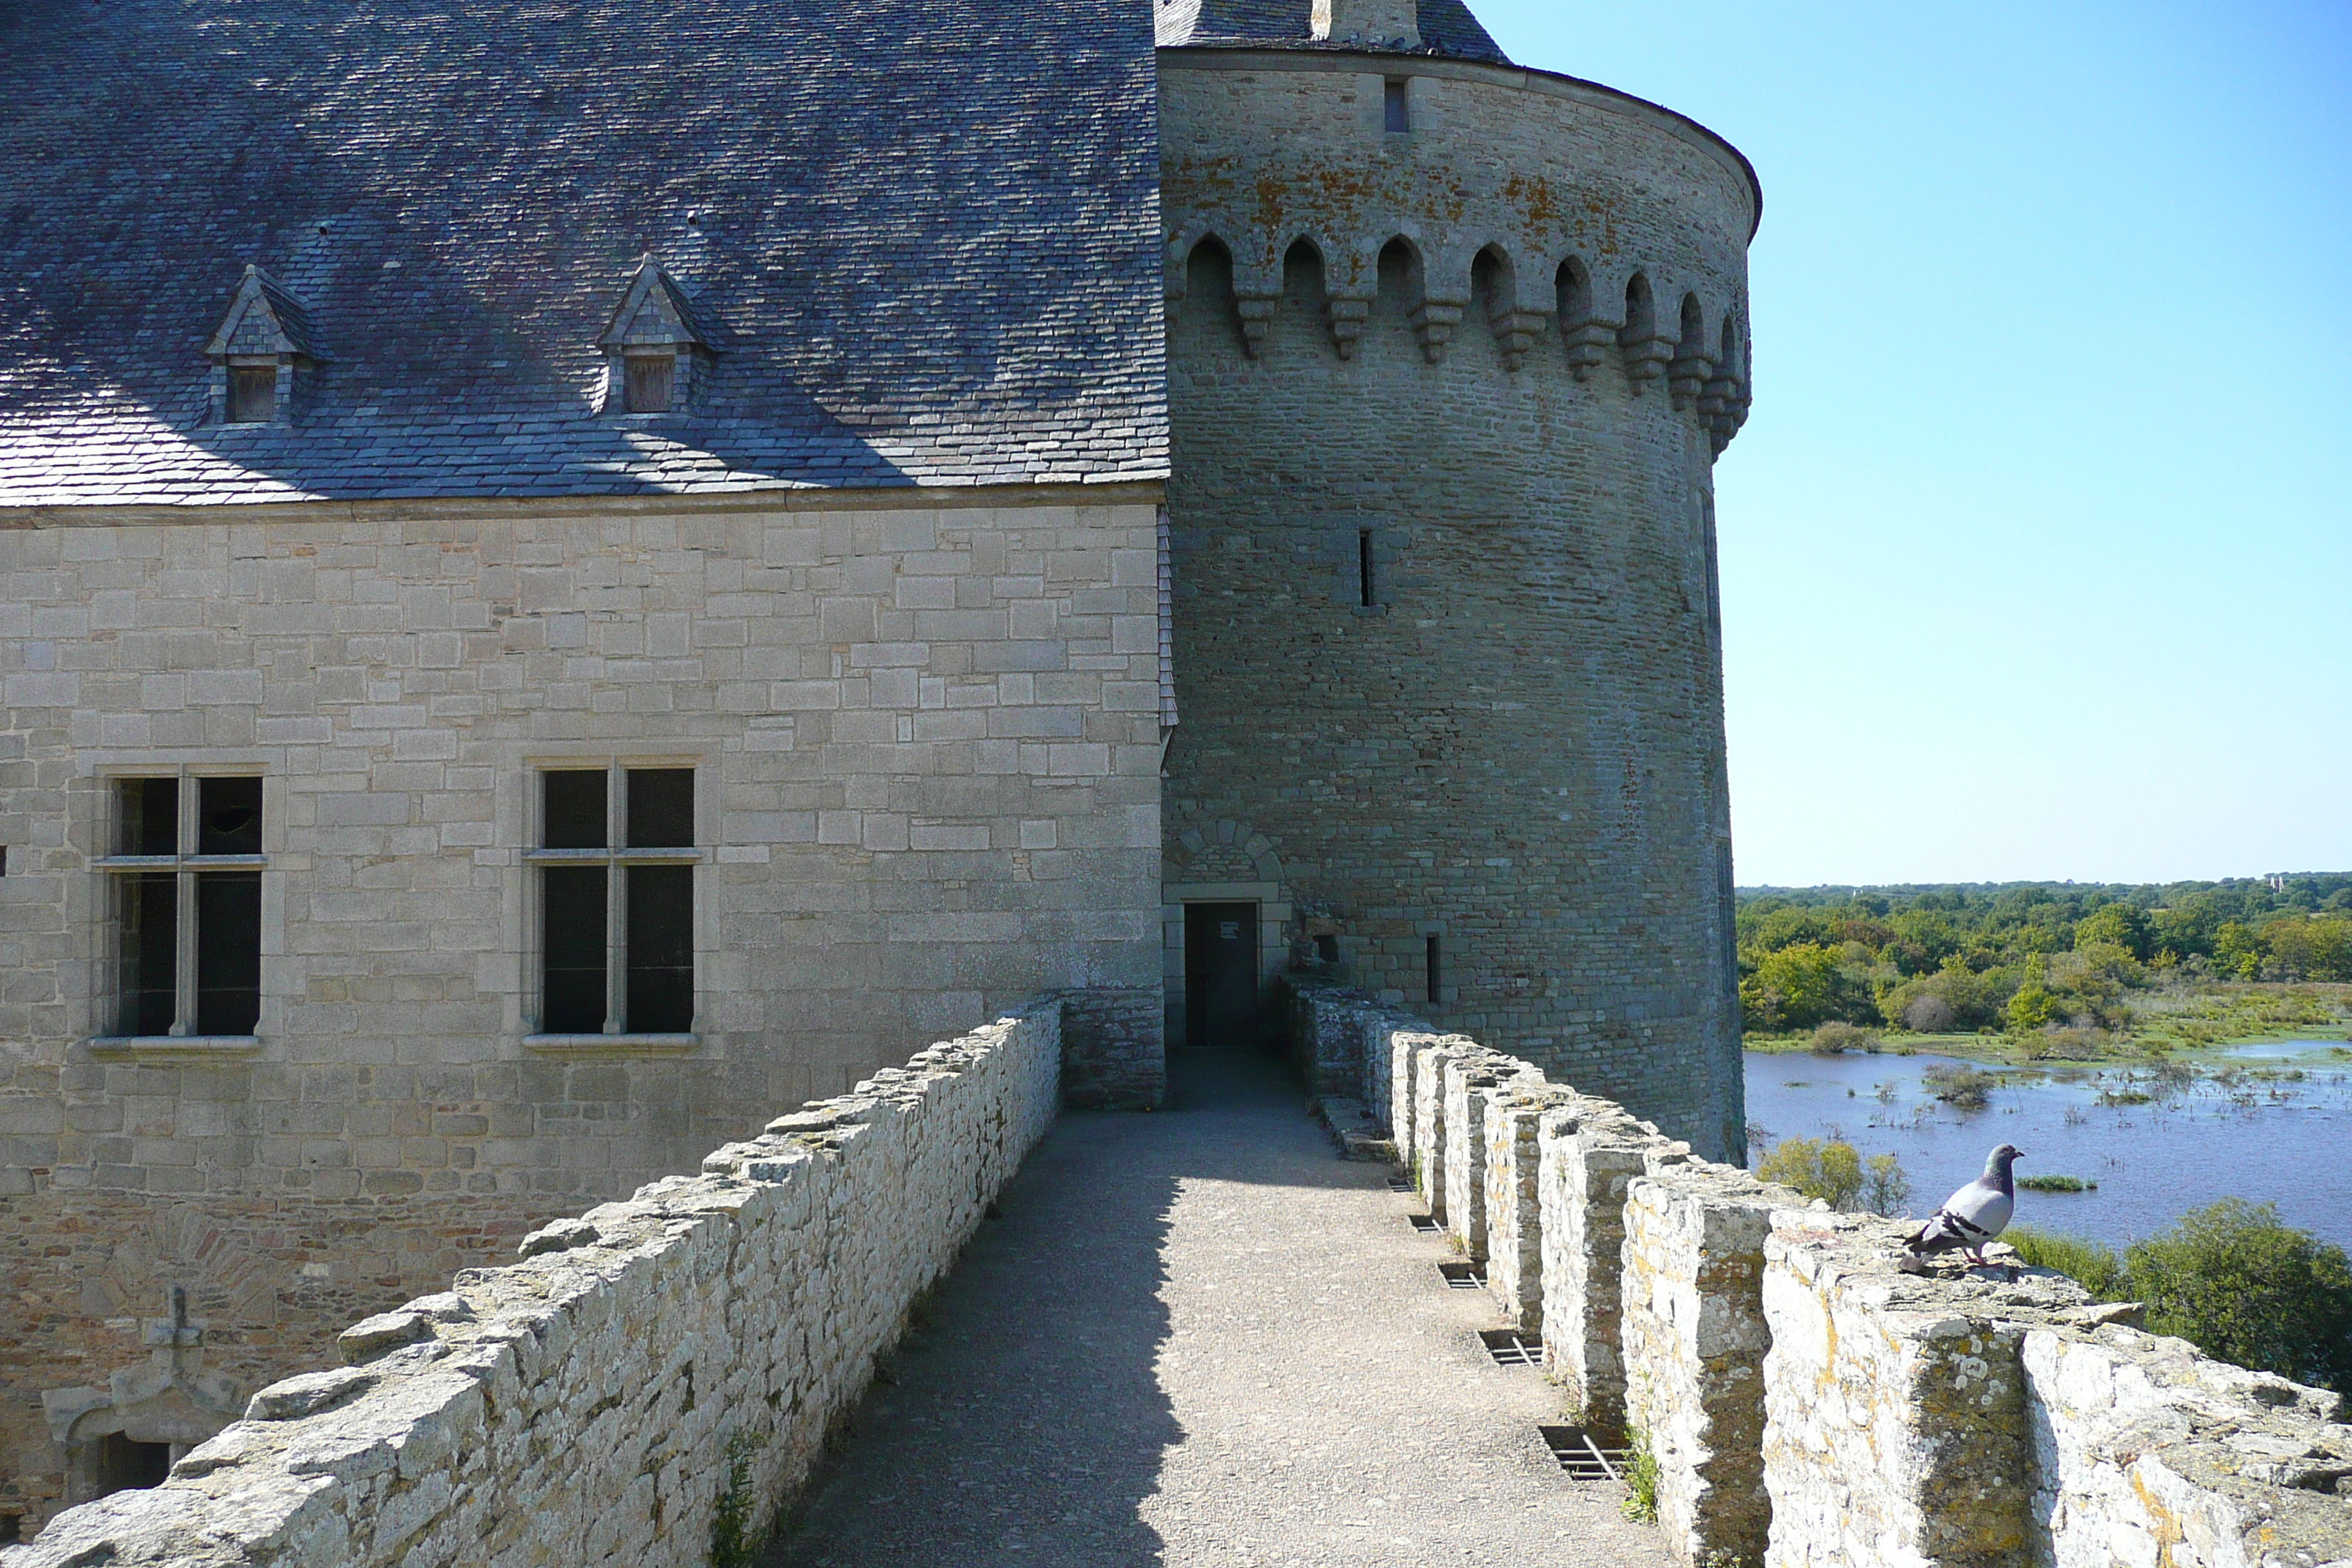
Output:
1472,0,2352,886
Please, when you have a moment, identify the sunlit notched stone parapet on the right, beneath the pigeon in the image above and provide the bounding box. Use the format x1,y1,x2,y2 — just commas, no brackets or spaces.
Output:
1289,983,2352,1568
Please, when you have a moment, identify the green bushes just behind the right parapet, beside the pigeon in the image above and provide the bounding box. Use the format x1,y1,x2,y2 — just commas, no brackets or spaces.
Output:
2002,1199,2352,1394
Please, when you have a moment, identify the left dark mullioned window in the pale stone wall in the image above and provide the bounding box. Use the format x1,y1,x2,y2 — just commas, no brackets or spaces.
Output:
99,776,265,1037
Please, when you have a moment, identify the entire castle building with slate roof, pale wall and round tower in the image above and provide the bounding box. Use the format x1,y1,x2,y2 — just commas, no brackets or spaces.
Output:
0,0,1762,1533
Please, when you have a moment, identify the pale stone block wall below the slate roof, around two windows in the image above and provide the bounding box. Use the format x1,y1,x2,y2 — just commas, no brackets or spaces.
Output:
0,486,1159,1526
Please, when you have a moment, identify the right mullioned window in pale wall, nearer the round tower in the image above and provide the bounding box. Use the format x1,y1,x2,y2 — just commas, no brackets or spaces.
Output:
532,766,701,1034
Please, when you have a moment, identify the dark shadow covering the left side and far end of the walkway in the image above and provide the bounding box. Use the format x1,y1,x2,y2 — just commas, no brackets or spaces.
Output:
764,1053,1308,1568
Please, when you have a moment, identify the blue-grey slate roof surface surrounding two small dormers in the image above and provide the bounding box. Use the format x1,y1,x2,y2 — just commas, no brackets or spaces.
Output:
0,0,1166,508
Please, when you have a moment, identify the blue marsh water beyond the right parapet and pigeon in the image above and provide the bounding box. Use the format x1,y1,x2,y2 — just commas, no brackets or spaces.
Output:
1747,1039,2352,1248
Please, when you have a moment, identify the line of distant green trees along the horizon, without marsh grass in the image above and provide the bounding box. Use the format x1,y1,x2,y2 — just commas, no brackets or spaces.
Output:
1738,872,2352,1034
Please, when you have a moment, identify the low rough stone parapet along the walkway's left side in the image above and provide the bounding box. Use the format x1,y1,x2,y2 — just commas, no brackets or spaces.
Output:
0,999,1063,1568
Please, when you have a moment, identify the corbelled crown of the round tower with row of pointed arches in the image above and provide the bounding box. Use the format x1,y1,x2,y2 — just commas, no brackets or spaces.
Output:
1162,52,1760,451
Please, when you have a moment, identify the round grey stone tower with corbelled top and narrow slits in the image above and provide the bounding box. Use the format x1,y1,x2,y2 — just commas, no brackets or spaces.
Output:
1159,0,1762,1159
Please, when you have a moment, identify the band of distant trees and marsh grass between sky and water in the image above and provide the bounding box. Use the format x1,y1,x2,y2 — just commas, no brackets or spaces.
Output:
1738,875,2352,1060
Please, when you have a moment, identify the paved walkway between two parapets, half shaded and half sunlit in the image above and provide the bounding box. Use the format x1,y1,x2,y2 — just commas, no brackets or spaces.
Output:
766,1060,1667,1568
